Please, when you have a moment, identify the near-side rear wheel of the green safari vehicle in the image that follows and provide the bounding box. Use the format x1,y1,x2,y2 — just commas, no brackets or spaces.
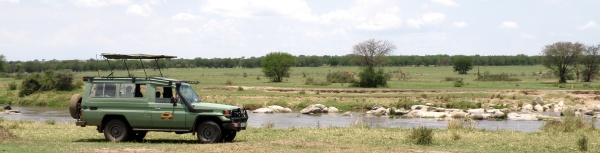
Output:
104,119,133,142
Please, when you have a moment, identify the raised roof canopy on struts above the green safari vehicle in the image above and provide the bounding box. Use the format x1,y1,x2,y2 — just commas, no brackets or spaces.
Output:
101,53,177,78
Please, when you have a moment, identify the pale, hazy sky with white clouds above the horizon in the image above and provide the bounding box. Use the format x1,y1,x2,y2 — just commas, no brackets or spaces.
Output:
0,0,600,61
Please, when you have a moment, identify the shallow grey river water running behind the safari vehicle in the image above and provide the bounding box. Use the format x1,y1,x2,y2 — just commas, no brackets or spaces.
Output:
0,107,600,132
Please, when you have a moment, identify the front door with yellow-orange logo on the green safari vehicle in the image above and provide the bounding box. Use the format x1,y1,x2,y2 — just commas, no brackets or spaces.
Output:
148,86,186,129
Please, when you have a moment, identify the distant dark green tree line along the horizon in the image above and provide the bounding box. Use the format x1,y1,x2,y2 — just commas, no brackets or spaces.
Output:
0,54,543,73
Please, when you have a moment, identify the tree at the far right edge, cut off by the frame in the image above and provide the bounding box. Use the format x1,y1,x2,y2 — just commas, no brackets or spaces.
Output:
580,44,600,82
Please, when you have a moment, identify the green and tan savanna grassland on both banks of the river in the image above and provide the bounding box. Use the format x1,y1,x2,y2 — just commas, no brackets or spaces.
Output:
0,65,600,152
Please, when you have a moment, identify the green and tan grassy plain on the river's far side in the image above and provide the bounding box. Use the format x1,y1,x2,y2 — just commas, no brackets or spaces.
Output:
0,65,600,110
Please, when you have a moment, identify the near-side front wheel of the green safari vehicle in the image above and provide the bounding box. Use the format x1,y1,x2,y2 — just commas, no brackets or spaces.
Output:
196,121,222,143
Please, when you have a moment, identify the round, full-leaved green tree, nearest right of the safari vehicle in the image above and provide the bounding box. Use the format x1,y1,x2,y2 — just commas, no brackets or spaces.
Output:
260,52,296,82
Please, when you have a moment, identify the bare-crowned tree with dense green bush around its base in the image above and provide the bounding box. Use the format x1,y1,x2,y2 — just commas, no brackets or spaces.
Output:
352,39,396,88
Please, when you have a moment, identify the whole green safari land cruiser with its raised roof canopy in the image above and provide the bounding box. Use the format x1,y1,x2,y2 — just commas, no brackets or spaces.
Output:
69,53,248,143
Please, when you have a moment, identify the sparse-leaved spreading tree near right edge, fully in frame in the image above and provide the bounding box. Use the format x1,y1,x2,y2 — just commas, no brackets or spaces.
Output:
542,42,585,83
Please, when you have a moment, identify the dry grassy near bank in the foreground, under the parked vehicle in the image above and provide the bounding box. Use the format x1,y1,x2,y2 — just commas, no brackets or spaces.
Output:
0,120,600,152
